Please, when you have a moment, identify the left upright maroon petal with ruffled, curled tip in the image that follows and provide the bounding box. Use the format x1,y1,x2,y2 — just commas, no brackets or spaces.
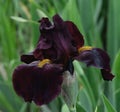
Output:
33,18,54,60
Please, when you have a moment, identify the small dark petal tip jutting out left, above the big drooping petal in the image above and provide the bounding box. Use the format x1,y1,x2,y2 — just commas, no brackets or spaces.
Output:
21,52,37,64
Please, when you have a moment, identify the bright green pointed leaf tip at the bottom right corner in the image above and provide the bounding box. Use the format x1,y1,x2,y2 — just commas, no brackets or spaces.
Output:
102,95,117,112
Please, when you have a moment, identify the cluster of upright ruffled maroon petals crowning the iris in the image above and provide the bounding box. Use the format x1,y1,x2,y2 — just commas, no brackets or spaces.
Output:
34,15,84,64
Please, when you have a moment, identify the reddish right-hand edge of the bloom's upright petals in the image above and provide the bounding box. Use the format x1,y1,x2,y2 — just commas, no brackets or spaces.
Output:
65,21,84,48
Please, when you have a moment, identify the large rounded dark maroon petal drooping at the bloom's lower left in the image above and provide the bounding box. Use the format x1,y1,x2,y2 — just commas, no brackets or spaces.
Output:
13,63,63,105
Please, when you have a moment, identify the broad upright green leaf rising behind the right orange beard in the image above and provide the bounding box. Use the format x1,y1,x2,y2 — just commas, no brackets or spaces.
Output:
78,0,102,47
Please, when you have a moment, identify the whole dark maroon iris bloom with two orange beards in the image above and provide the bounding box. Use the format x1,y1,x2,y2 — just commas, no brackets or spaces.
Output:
13,15,114,105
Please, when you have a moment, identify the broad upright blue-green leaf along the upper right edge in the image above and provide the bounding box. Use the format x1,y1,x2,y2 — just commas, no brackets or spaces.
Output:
107,0,120,62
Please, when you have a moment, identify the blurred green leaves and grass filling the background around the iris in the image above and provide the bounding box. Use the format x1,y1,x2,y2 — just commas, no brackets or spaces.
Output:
0,0,120,112
